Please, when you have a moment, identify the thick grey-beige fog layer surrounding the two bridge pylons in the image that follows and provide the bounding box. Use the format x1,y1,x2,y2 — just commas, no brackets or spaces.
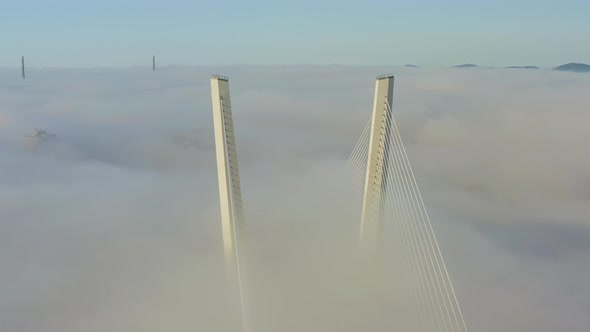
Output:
0,66,590,332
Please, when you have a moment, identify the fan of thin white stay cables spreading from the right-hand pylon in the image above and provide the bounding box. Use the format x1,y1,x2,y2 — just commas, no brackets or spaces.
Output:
347,82,467,332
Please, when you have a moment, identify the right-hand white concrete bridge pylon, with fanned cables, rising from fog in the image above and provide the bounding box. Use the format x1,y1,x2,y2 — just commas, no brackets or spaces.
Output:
359,75,394,248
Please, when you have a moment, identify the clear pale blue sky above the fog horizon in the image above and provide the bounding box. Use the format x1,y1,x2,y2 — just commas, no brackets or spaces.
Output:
0,0,590,67
